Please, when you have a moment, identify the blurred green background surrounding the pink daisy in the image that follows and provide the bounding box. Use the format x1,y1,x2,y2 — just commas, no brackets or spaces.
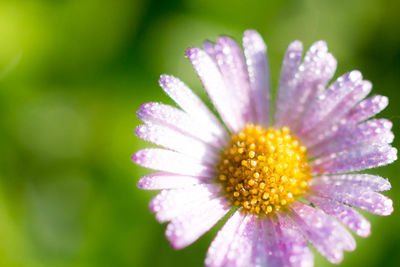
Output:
0,0,400,267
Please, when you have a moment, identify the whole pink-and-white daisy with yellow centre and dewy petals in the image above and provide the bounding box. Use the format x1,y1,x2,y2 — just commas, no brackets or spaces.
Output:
132,30,397,266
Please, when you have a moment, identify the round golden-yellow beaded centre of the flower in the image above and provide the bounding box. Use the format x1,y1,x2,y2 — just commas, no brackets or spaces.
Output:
217,124,311,215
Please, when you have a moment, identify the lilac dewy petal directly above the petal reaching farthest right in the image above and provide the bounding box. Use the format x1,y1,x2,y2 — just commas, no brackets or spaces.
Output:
308,119,394,157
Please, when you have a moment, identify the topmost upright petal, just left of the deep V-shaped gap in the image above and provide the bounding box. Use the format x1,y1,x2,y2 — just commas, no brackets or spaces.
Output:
243,30,270,126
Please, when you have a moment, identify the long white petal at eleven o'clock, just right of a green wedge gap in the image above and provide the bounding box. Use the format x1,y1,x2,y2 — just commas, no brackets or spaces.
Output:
186,47,239,132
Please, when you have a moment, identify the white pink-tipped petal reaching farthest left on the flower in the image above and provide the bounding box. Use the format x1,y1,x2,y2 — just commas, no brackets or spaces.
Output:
132,148,216,177
